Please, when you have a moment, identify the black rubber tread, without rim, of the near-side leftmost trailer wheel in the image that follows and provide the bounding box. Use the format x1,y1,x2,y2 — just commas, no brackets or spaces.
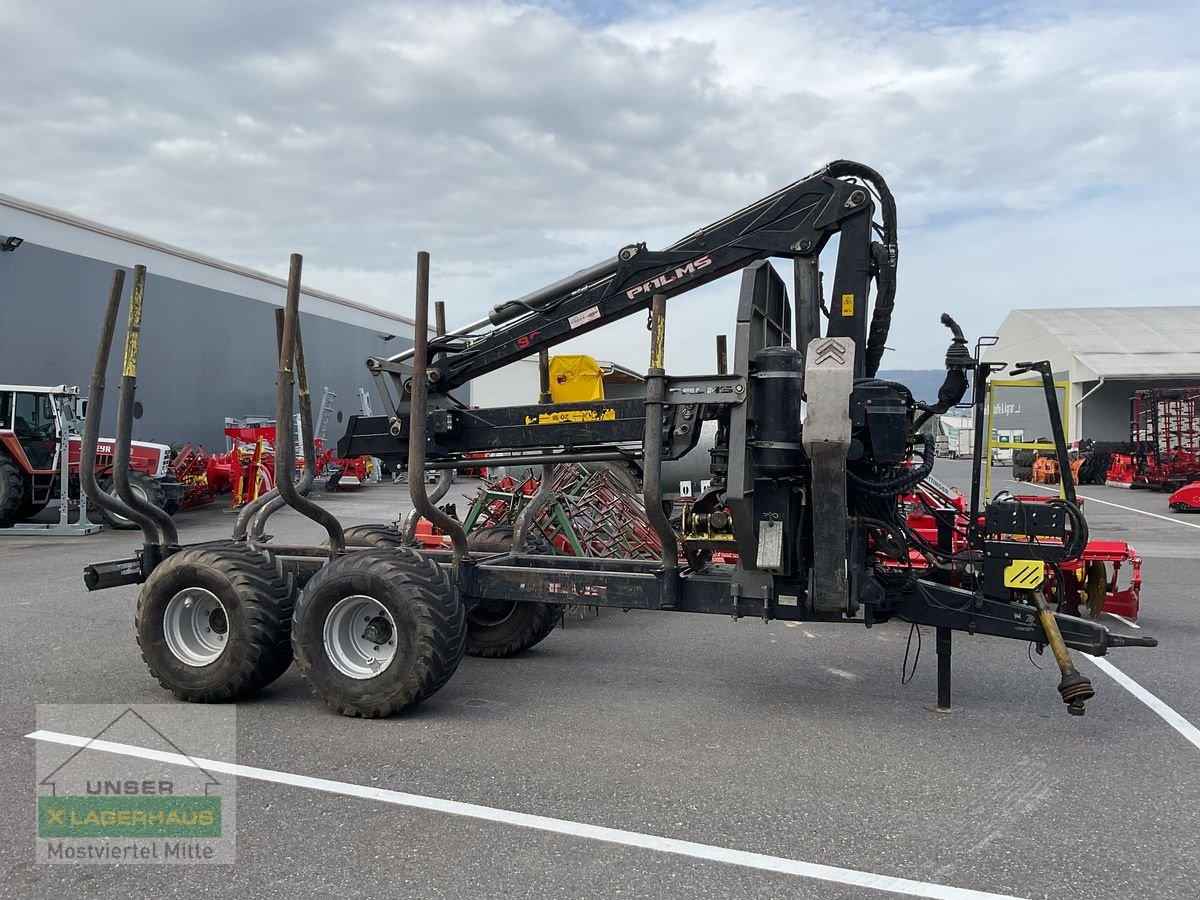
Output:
136,545,293,703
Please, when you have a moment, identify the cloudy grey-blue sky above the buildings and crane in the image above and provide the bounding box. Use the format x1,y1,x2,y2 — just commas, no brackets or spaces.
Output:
0,0,1200,373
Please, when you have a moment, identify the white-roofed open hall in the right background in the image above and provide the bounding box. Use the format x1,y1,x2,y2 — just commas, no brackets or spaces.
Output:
984,306,1200,440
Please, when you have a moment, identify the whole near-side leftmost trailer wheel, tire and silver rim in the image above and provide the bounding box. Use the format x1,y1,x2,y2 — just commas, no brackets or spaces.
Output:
136,545,293,703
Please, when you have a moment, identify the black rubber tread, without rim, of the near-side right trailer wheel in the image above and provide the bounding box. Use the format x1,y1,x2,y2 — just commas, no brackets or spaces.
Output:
292,547,467,719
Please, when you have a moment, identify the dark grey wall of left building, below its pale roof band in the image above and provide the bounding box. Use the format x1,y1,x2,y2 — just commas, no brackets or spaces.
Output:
0,241,412,448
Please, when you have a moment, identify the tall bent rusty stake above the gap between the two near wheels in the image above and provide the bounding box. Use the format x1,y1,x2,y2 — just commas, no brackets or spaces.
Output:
275,253,346,559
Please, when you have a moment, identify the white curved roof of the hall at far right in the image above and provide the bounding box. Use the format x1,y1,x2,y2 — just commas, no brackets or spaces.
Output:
988,306,1200,382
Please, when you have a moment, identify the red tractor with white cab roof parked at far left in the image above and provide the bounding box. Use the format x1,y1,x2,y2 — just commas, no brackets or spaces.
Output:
0,384,184,528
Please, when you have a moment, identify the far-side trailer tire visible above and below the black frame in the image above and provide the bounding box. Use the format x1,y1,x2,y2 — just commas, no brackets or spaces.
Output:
467,526,563,659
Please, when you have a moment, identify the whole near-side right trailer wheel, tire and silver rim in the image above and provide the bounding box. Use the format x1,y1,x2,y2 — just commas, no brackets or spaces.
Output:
292,547,467,719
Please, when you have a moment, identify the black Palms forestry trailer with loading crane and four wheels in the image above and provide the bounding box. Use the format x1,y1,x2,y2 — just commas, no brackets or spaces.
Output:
85,161,1156,715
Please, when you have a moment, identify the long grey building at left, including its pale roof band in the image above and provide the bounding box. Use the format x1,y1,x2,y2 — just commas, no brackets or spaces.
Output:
0,194,413,448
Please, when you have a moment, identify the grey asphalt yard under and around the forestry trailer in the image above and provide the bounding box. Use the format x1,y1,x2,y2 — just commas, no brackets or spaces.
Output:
0,461,1200,900
